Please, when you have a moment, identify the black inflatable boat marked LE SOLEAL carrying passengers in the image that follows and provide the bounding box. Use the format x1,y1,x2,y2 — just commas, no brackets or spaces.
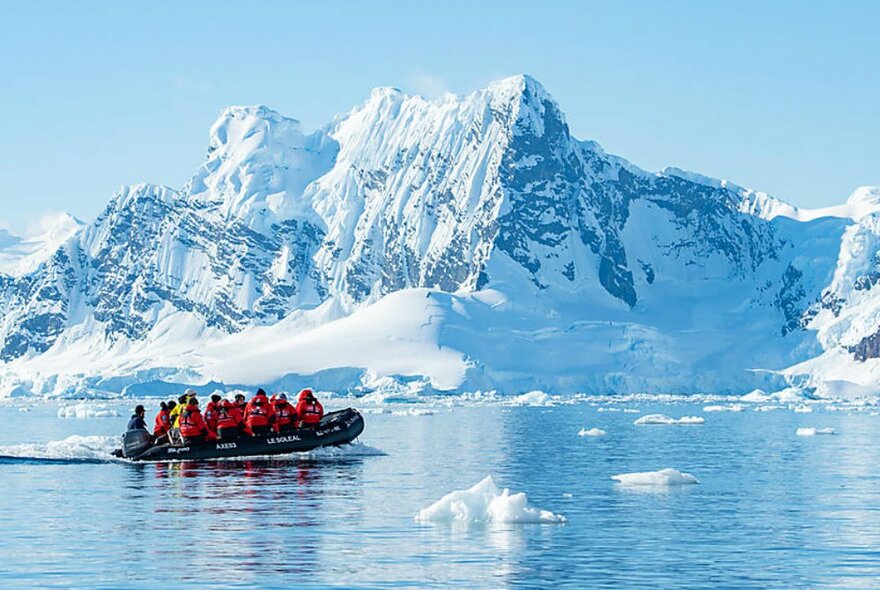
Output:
113,408,364,461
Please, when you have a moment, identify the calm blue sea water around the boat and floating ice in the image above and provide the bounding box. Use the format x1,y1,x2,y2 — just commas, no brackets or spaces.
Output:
0,402,880,588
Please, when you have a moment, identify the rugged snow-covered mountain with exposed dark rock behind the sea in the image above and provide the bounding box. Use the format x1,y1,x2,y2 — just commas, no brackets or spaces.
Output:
0,76,880,393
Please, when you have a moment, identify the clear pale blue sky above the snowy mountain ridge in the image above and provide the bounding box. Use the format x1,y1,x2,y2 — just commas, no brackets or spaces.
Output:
0,0,880,228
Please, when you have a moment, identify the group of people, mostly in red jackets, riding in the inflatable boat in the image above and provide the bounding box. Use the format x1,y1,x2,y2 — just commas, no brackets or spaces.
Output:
128,389,324,443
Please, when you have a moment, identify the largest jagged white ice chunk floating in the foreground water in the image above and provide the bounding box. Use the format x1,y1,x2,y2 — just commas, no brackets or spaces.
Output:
415,476,565,523
